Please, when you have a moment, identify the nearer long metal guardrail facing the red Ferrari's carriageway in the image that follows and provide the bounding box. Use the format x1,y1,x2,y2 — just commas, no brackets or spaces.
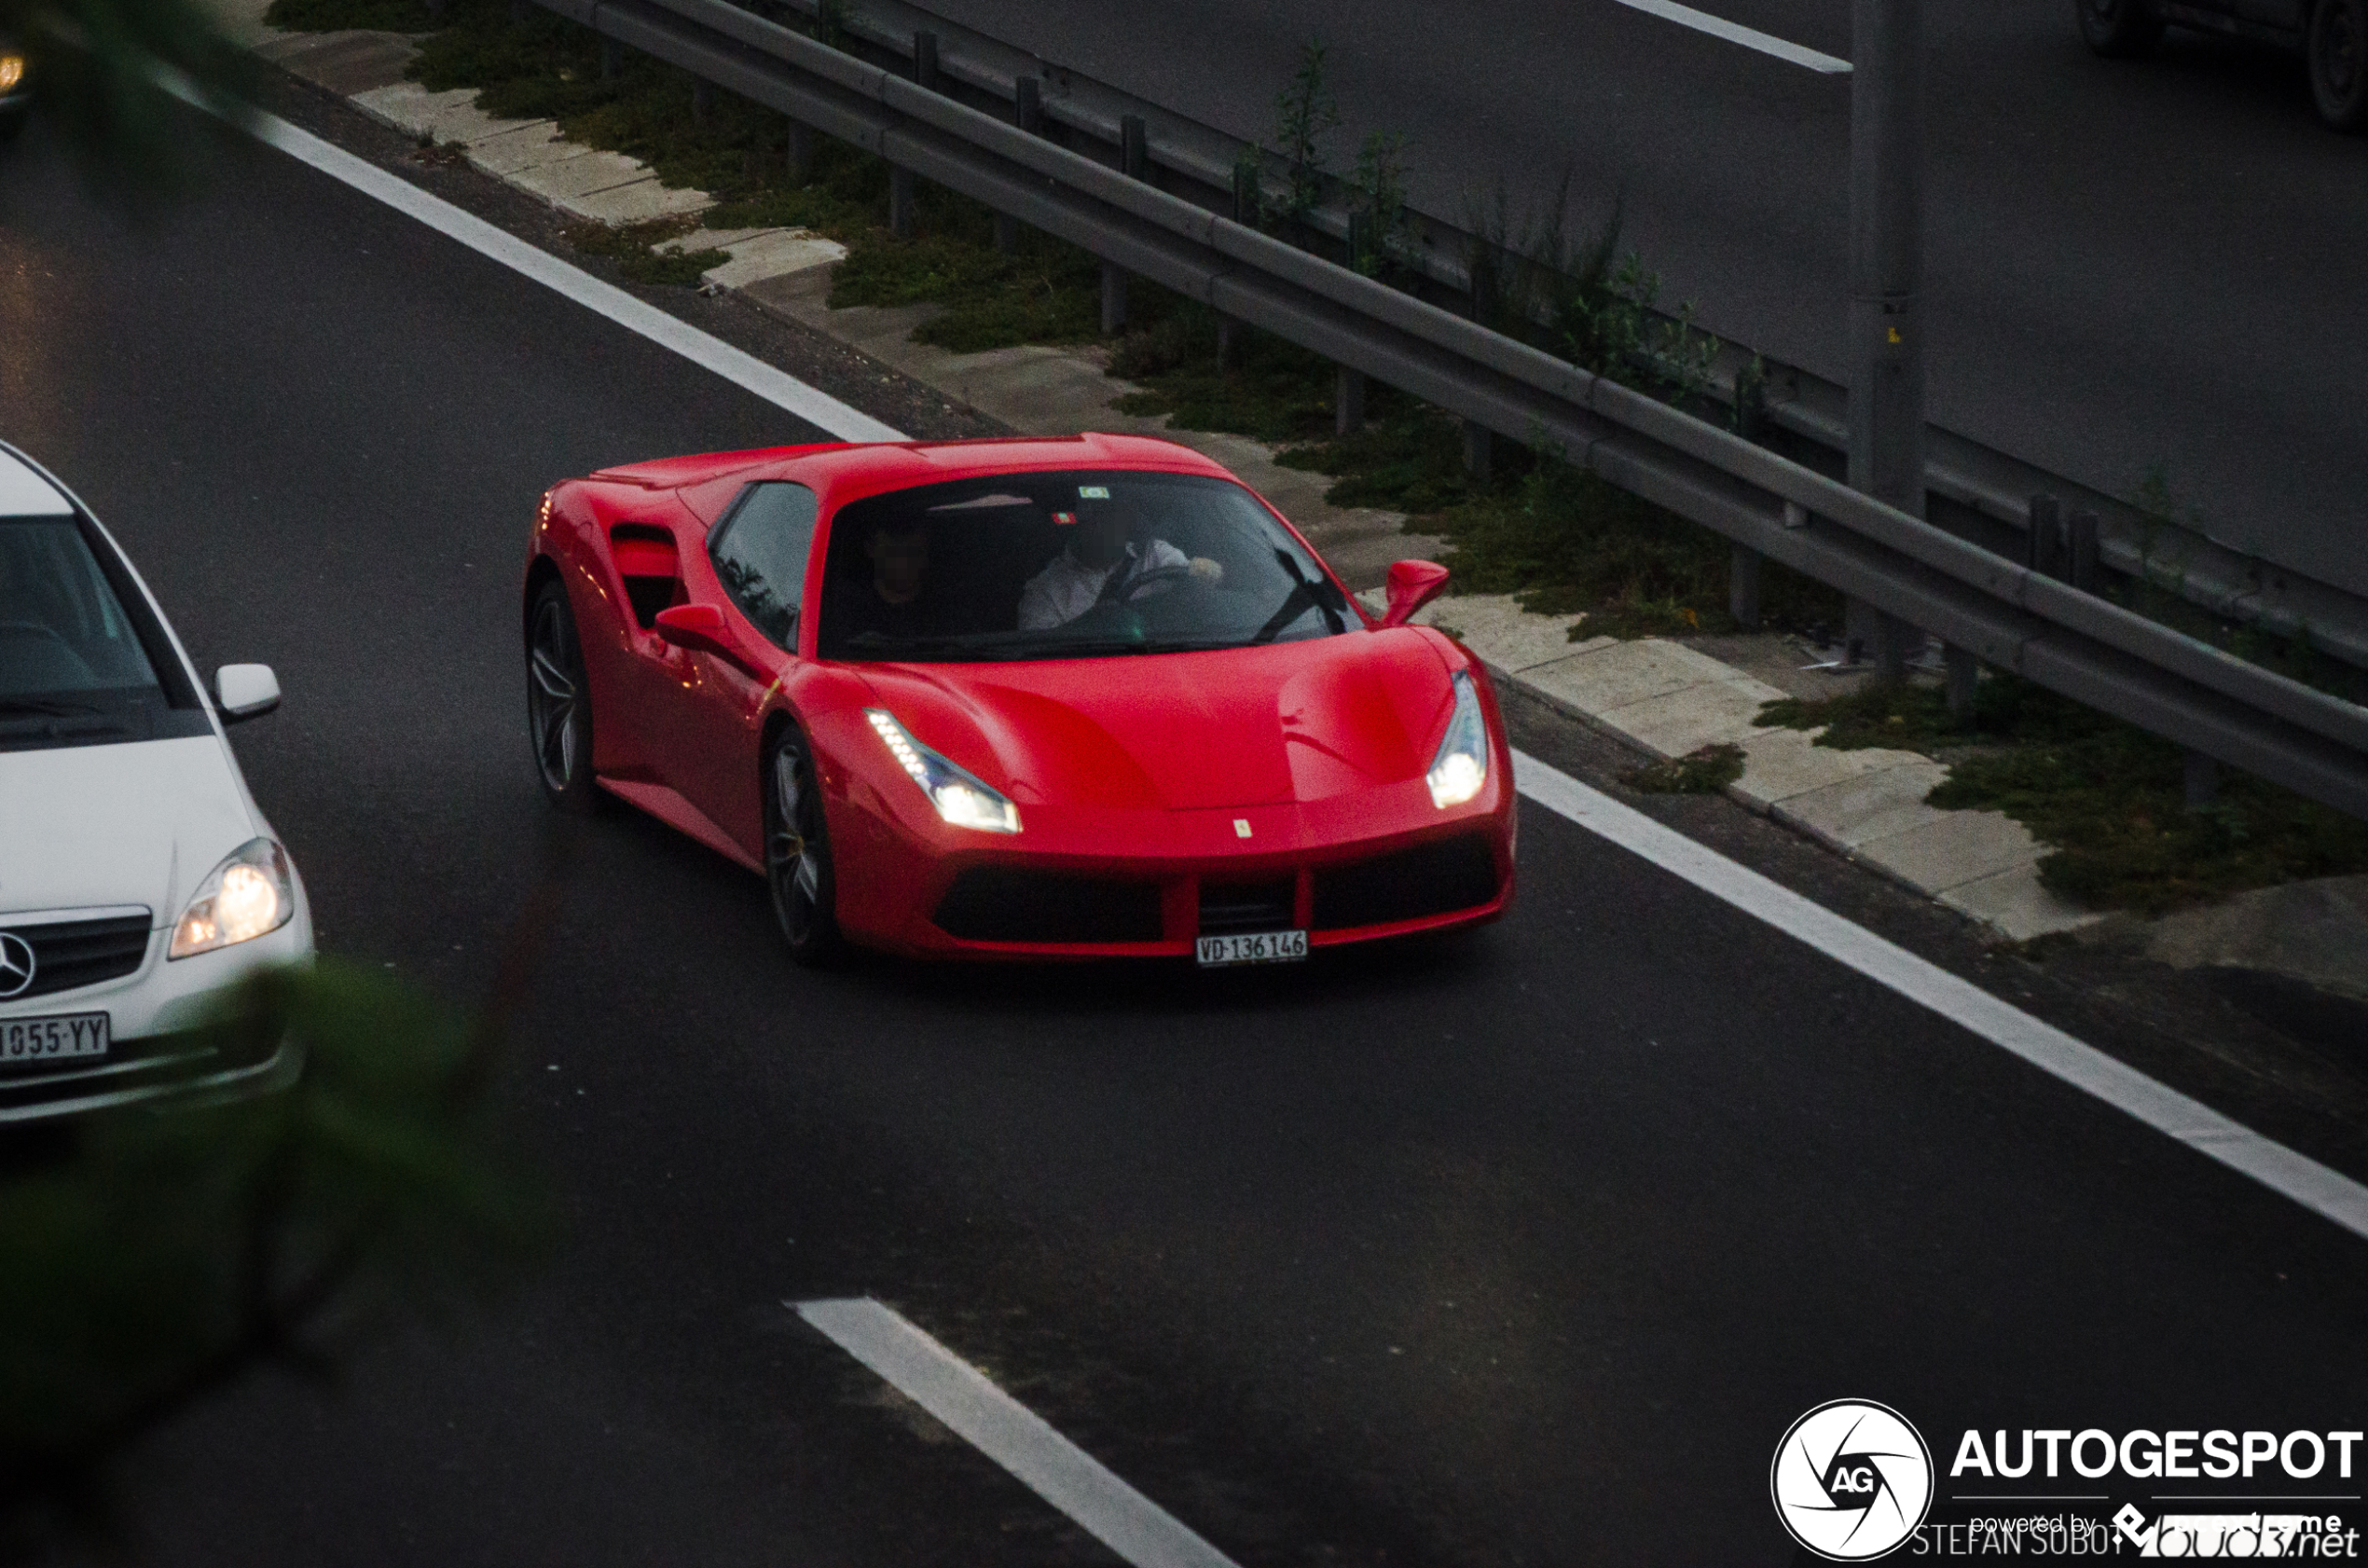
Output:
538,0,2368,818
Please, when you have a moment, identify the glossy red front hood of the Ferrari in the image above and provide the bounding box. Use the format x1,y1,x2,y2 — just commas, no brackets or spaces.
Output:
867,630,1454,810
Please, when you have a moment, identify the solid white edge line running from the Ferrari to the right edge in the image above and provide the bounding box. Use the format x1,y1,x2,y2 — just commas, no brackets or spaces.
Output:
1513,750,2368,1236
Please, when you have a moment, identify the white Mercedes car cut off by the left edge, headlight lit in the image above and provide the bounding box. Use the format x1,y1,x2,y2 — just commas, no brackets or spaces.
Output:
0,443,312,1122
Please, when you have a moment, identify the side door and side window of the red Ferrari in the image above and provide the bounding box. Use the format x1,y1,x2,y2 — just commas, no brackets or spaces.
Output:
668,481,819,853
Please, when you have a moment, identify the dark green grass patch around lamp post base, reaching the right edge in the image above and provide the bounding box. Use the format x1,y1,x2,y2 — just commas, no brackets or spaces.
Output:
1759,675,2368,915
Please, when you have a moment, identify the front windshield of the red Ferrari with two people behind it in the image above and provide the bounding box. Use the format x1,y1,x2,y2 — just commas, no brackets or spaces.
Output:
817,469,1364,663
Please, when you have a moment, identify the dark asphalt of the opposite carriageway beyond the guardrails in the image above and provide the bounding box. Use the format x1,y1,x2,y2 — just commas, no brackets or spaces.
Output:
929,0,2368,595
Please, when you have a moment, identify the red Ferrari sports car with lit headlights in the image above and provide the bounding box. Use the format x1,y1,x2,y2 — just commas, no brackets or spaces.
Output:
523,436,1513,964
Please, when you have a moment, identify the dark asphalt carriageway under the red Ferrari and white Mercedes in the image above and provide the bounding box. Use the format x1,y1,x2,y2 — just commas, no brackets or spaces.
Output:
0,95,2368,1568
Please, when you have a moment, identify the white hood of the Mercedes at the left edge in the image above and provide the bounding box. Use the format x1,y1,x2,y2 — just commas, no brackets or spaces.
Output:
0,735,260,924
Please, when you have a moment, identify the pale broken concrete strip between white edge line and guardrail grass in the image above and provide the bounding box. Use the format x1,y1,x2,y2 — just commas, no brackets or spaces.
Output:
218,0,2103,941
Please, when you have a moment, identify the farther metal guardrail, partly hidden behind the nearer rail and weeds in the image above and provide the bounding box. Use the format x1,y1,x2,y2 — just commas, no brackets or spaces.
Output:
755,0,2368,668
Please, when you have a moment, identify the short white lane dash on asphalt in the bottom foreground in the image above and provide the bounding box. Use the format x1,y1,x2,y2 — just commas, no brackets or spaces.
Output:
784,1296,1236,1568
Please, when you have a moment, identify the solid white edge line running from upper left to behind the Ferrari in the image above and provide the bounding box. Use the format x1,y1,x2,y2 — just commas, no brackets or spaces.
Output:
163,80,904,441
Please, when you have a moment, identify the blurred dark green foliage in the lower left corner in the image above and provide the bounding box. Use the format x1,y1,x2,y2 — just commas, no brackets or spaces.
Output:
0,959,547,1559
